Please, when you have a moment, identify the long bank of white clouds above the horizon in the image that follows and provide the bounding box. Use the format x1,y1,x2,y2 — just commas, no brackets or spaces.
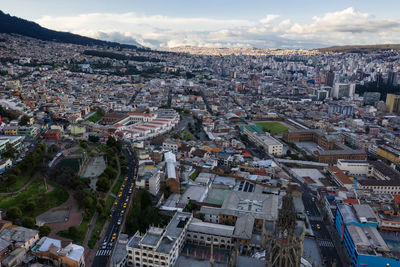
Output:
36,7,400,48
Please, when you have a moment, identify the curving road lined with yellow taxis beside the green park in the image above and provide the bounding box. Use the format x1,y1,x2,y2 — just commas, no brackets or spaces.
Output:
92,146,137,267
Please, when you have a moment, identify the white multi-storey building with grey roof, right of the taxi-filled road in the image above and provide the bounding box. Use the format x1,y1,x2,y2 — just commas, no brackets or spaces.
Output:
127,212,193,267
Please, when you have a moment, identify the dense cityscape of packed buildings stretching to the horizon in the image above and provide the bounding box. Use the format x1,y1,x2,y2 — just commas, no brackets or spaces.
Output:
0,4,400,267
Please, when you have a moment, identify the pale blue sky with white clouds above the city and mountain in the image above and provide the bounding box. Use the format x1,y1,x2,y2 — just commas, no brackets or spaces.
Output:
0,0,400,49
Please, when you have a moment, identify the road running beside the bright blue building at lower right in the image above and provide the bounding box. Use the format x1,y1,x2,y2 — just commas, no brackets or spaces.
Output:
302,184,343,267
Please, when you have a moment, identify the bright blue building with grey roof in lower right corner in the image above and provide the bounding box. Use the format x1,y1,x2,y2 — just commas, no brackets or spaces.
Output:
335,203,400,267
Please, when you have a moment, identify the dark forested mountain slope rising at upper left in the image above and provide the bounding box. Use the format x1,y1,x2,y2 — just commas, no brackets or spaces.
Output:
0,10,143,49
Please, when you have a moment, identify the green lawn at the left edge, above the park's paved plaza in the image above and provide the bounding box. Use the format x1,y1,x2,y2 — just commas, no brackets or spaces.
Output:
0,180,68,217
